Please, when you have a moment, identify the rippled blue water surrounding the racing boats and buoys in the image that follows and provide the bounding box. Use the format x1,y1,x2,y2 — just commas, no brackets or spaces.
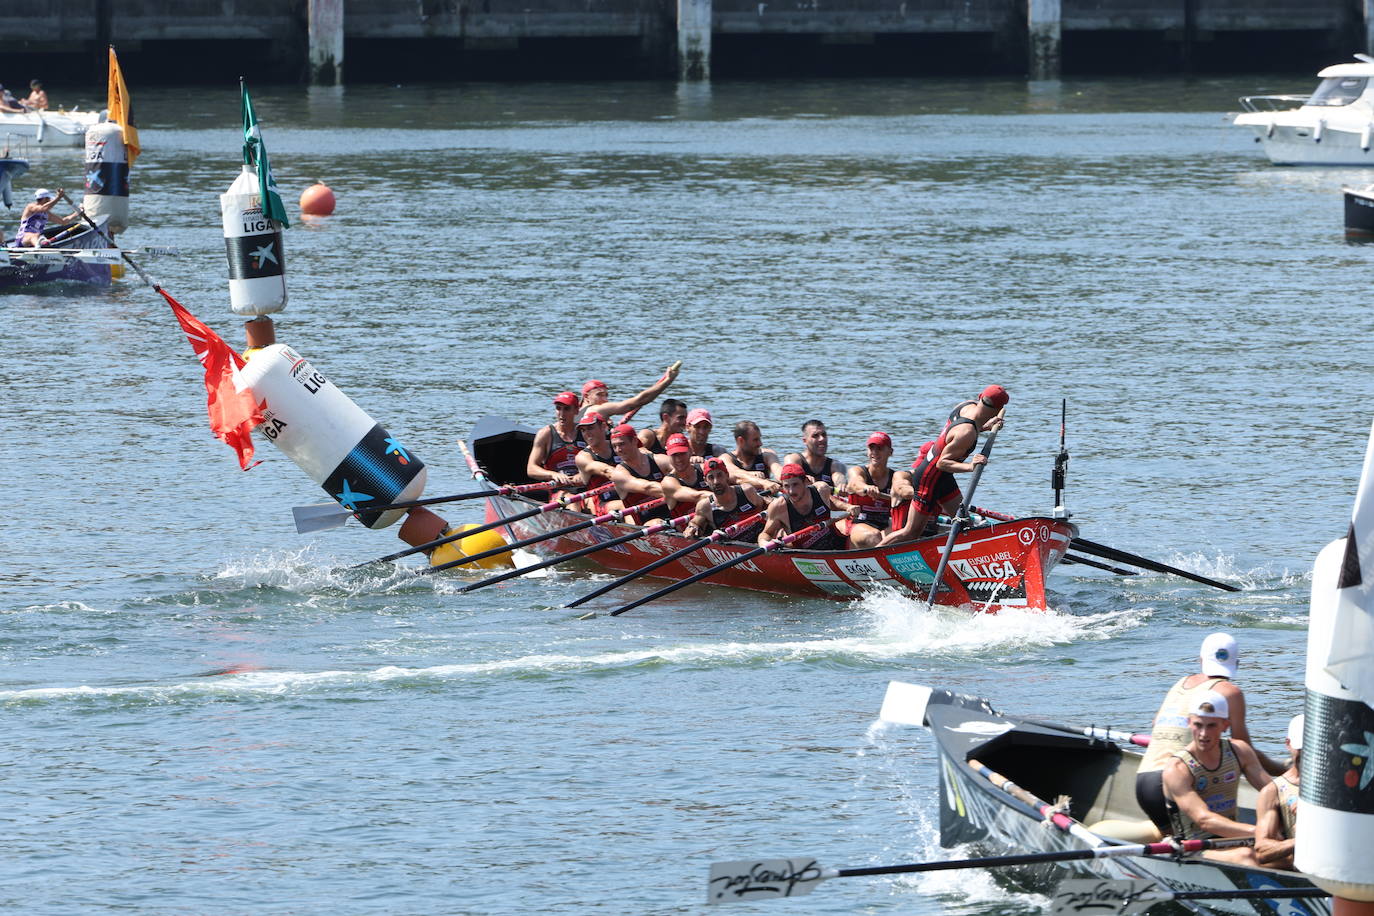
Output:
0,78,1374,915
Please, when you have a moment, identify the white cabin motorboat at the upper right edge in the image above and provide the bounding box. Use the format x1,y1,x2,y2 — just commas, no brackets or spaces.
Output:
1232,54,1374,165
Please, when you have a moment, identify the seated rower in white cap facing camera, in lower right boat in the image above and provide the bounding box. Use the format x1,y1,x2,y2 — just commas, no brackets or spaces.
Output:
1164,691,1271,865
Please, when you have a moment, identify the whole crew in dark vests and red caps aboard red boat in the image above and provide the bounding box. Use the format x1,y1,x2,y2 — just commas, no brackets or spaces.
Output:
526,364,1009,549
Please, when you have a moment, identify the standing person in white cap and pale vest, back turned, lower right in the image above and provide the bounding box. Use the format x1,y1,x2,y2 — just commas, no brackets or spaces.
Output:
1135,633,1283,834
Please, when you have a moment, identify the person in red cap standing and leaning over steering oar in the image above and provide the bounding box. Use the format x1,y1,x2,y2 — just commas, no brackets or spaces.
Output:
881,385,1010,547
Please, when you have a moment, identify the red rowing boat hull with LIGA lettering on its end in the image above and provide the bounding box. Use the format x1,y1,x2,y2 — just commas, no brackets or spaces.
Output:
471,417,1079,612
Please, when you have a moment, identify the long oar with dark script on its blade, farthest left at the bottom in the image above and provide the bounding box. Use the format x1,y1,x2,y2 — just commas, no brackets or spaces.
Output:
706,836,1254,904
